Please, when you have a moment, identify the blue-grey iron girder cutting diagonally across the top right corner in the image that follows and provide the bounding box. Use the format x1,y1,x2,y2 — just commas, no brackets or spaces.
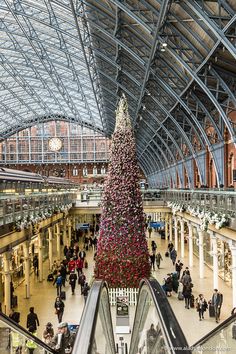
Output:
184,1,236,59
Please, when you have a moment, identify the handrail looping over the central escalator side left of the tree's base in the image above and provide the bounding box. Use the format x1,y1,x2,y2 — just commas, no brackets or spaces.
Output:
72,280,115,354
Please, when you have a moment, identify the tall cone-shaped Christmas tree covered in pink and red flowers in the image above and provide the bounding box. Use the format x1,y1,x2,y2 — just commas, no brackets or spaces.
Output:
95,96,150,287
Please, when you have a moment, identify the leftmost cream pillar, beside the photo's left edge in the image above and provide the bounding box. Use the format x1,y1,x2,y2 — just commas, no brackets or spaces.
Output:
3,252,11,316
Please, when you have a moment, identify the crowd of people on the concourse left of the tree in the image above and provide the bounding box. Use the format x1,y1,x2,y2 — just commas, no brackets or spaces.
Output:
6,229,97,354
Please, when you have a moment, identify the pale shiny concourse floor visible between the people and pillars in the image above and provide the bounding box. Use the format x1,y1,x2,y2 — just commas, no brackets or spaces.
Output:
12,232,232,352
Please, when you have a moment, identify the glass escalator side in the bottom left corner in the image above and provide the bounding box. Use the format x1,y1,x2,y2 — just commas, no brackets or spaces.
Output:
0,313,56,354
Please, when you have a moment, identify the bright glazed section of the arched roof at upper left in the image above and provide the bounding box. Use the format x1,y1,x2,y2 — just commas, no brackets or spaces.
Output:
0,0,103,138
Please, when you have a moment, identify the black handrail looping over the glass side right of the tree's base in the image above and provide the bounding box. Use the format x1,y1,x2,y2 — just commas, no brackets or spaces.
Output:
130,278,191,354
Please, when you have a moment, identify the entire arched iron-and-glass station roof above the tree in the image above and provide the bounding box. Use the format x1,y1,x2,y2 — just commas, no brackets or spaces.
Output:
0,0,236,180
